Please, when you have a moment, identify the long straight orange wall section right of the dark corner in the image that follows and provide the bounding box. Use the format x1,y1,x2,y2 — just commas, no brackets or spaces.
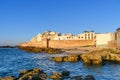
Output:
49,40,94,48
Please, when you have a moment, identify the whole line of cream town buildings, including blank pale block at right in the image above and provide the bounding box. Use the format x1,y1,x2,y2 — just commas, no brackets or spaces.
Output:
30,28,116,47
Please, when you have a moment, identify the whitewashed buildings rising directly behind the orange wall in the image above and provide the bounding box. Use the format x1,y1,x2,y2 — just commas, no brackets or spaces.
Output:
31,31,95,42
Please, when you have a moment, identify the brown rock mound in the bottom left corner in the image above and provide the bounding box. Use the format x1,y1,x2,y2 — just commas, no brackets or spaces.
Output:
0,68,47,80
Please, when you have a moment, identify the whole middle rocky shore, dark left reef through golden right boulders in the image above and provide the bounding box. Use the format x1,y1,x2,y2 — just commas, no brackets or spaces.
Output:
18,47,120,65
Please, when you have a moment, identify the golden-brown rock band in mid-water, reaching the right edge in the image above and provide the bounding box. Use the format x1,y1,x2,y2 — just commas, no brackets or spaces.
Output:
50,49,120,64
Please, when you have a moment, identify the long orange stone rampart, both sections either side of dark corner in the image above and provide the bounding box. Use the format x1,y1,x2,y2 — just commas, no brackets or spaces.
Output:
19,40,94,48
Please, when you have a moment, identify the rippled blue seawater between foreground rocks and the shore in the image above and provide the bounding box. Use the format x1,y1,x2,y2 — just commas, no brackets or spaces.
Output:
0,48,120,80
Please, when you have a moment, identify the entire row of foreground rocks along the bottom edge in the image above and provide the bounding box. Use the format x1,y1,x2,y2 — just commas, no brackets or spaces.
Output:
0,68,95,80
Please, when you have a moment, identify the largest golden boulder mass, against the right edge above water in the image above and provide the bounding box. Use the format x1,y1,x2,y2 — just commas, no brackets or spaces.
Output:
81,49,120,64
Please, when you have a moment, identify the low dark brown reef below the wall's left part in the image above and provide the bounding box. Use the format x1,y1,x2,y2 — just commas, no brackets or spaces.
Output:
18,46,62,54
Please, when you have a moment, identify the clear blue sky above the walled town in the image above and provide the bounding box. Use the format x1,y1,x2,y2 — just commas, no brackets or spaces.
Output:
0,0,120,45
